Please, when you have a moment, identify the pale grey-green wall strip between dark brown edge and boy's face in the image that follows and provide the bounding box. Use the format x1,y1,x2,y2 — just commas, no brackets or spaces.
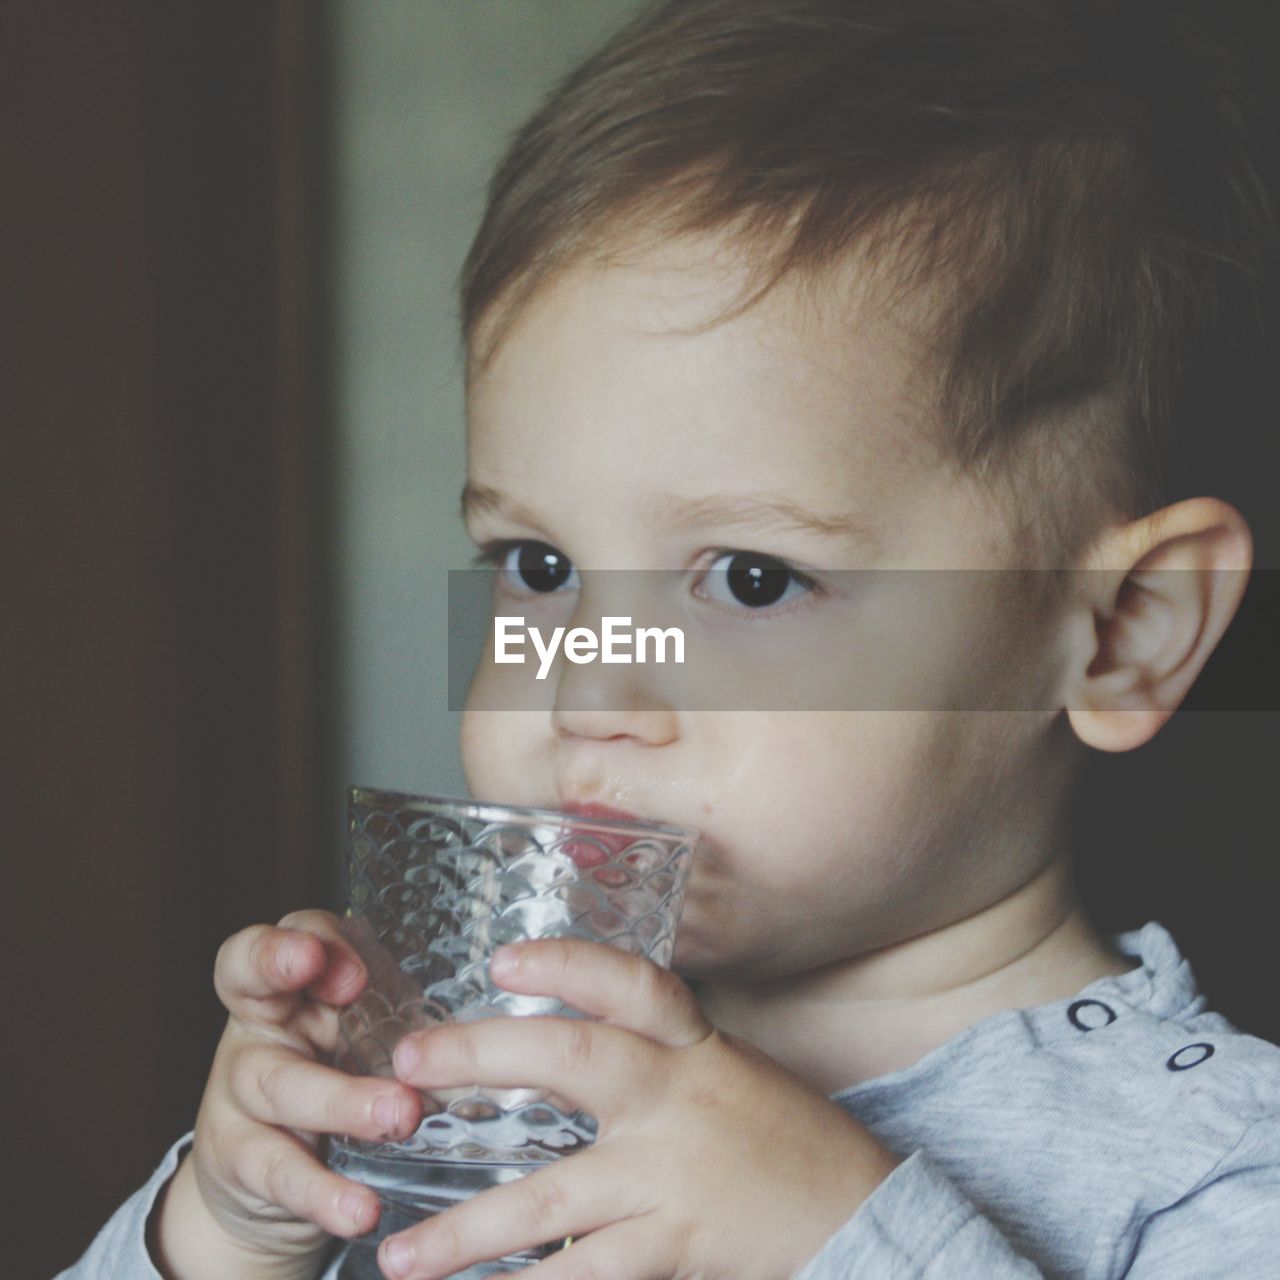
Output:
326,0,639,805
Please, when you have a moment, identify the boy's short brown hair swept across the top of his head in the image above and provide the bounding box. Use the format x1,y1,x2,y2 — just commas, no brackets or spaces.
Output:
462,0,1274,550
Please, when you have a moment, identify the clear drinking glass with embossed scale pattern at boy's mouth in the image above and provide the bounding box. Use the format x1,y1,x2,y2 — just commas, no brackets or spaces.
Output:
329,787,698,1280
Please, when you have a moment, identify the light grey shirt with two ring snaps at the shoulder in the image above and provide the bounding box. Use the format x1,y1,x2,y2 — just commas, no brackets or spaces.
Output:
59,924,1280,1280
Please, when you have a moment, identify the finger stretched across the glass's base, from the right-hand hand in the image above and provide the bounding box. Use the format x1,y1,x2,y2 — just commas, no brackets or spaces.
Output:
378,1151,630,1280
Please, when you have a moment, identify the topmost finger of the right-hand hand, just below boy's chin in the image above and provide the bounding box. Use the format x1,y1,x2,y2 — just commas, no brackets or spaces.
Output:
489,938,712,1048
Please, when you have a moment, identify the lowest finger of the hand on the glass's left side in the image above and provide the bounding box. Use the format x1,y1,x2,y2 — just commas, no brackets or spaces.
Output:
233,1129,381,1239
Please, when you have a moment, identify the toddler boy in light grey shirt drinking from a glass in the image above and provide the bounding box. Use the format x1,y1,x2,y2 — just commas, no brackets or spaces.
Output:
70,0,1280,1280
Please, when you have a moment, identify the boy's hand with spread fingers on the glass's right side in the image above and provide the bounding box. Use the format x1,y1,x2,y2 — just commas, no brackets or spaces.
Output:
379,941,897,1280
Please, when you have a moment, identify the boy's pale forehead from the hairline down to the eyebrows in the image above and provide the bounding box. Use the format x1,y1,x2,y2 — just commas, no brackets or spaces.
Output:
468,238,1034,562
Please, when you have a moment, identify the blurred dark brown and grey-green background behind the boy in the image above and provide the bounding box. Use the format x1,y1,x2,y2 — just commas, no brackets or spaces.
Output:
0,0,1280,1276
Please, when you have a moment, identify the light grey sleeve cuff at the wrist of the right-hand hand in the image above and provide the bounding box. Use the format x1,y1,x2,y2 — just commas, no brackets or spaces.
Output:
796,1151,1044,1280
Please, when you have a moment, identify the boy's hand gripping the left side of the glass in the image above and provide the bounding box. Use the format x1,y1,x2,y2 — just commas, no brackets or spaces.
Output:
152,911,422,1280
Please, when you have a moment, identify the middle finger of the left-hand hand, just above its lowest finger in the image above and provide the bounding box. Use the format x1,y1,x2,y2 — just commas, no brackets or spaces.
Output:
230,1044,422,1142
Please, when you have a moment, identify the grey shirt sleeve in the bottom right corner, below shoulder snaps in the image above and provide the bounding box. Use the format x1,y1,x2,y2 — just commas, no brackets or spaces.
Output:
1125,1115,1280,1280
